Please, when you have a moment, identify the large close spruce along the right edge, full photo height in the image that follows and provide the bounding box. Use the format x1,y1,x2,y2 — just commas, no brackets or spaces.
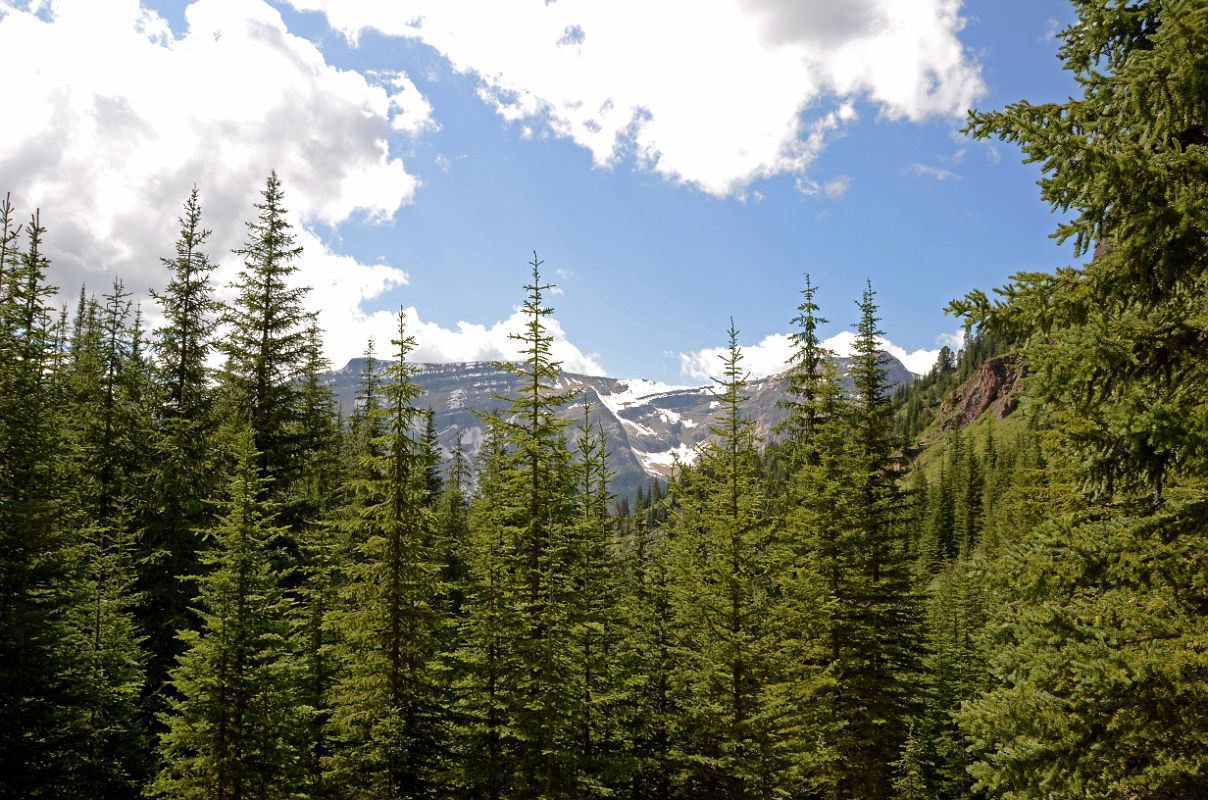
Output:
953,0,1208,798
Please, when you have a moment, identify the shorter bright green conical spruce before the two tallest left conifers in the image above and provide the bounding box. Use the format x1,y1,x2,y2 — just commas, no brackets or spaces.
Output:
149,431,312,800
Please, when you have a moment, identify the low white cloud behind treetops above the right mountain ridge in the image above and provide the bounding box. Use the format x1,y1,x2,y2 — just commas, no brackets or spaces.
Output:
676,330,964,381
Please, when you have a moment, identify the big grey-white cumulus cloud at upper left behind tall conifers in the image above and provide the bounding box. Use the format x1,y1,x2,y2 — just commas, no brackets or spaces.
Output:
0,0,435,362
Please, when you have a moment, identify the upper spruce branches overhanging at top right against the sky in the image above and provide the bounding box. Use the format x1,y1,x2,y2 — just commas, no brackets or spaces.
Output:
951,0,1208,502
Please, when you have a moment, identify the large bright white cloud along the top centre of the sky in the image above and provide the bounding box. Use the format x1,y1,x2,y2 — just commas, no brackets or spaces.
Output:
288,0,983,196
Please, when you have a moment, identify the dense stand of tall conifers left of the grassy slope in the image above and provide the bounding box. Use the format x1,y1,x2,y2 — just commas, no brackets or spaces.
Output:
0,174,925,798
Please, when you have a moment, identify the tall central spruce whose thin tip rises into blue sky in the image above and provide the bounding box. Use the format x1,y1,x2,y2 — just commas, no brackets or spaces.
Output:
459,254,586,798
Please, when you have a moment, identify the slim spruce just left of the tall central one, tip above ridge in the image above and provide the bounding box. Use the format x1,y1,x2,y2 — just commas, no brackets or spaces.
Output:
325,313,446,798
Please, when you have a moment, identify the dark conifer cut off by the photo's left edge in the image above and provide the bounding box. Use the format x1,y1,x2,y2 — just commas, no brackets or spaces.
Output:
0,210,80,799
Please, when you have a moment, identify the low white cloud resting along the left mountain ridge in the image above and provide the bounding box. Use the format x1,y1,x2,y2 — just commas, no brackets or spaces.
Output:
337,307,605,375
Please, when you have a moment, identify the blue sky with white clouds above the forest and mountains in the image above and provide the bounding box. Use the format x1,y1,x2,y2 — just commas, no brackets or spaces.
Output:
0,0,1078,385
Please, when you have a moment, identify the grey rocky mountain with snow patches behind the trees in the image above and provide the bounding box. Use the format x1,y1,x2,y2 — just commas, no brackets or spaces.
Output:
325,354,914,497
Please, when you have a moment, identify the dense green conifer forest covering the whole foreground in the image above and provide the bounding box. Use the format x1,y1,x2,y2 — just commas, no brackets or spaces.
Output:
0,0,1208,800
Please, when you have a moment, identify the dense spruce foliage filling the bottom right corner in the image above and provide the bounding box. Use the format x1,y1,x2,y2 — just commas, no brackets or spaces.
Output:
959,499,1208,799
